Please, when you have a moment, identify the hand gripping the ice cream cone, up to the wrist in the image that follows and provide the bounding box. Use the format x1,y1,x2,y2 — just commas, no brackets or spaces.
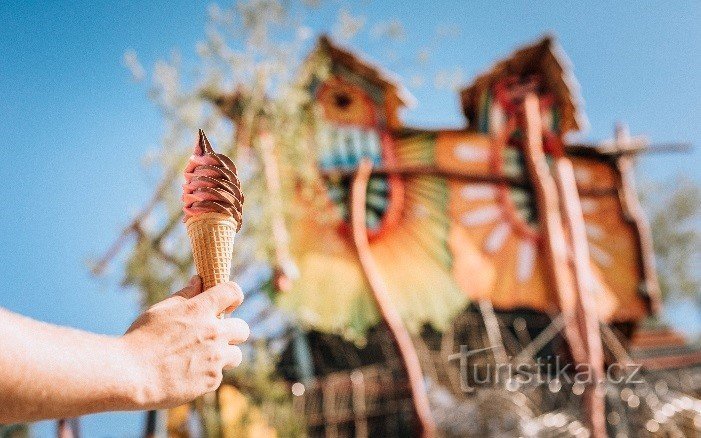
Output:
121,276,249,409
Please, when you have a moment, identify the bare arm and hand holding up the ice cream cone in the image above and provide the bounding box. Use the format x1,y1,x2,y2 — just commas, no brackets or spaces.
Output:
0,277,248,423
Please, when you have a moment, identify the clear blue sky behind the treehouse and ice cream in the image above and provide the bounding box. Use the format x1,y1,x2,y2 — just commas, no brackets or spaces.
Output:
0,0,701,437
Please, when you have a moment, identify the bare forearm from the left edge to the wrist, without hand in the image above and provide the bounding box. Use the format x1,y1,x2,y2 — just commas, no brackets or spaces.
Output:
0,309,143,423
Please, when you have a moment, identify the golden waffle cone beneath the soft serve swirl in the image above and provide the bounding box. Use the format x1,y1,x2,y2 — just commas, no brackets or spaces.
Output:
185,213,237,289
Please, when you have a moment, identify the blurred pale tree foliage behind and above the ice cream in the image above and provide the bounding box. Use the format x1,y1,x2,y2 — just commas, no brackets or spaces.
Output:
124,1,314,305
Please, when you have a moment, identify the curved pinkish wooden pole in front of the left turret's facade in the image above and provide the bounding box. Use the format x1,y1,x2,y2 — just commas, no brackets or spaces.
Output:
351,160,436,438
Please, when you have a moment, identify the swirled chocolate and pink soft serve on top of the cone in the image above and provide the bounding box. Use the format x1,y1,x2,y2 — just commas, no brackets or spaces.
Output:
183,129,243,231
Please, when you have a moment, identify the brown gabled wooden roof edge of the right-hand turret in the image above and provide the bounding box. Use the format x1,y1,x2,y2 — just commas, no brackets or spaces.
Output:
460,35,587,133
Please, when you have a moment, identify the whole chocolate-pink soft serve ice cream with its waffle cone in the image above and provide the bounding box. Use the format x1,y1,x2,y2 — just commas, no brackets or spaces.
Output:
183,129,243,289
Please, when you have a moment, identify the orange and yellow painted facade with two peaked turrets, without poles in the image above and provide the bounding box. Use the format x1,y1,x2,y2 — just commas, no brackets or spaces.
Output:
281,38,658,333
